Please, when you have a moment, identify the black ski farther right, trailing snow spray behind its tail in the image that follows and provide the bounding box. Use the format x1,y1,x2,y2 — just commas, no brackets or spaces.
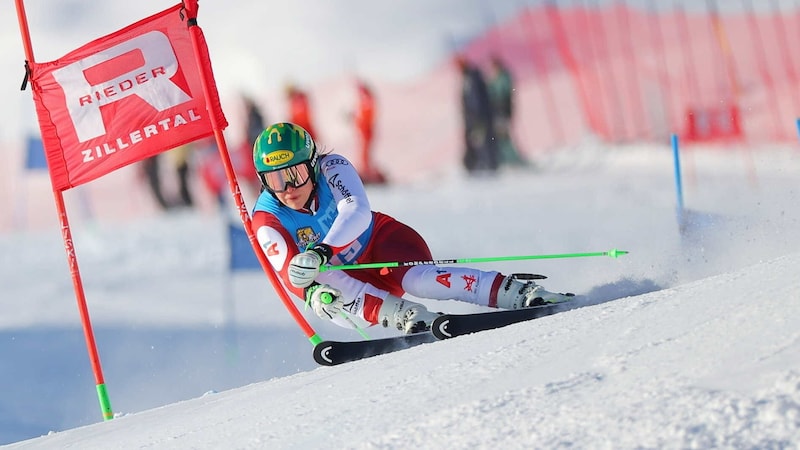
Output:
431,303,563,339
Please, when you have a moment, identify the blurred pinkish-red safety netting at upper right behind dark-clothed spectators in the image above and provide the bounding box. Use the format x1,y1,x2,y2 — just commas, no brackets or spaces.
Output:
456,0,800,145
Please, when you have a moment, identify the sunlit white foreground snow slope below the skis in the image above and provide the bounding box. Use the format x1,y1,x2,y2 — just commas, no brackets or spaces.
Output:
9,254,800,449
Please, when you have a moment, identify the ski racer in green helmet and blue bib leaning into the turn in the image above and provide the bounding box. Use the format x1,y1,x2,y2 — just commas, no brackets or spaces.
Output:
252,123,571,334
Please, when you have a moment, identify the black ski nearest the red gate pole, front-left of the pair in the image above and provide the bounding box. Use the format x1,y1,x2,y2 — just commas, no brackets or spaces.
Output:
314,332,436,366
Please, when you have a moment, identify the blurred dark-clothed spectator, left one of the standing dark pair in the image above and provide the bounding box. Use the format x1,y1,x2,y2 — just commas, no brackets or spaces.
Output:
456,55,498,173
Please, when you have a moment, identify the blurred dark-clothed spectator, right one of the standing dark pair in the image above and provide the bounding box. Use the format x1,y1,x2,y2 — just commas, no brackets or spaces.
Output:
489,56,526,166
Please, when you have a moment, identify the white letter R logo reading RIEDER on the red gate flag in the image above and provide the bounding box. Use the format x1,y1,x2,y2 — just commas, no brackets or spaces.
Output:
53,31,192,142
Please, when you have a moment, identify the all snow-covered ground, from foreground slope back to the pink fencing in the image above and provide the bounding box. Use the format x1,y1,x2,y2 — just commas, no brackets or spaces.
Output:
0,144,800,449
